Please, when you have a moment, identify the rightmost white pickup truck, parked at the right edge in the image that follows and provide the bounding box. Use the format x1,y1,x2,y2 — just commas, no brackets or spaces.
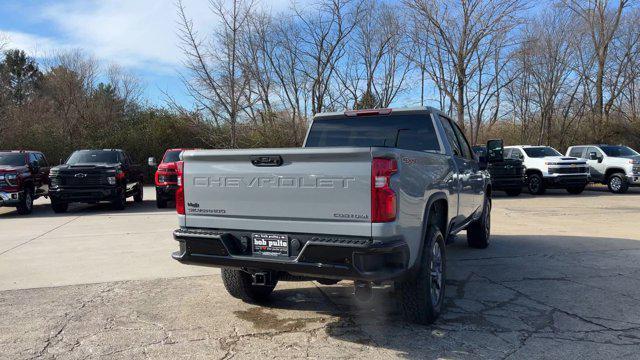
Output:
567,144,640,194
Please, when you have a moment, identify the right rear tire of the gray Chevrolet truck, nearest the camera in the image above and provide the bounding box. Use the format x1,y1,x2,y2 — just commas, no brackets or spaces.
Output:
396,226,446,325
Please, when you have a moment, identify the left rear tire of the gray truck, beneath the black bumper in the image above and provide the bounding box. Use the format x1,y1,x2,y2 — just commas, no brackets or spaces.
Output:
221,268,278,303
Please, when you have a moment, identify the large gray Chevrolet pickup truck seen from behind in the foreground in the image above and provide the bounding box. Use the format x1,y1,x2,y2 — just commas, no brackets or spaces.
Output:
172,108,491,324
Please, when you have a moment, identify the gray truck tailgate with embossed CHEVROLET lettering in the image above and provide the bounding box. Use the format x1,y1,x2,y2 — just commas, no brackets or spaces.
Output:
183,148,371,236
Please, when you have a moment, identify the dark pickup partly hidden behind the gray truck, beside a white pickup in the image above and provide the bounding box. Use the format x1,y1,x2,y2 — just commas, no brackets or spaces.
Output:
473,140,524,196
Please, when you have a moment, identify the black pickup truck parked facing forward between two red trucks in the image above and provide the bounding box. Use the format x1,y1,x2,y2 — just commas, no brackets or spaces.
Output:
49,149,143,213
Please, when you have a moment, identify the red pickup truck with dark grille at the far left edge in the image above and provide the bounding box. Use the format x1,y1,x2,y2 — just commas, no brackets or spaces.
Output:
0,150,49,215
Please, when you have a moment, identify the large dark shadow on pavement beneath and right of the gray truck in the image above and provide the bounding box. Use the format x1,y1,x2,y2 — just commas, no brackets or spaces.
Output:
252,236,640,359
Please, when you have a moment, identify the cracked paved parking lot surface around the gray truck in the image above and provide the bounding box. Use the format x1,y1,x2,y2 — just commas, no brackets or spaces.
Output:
0,188,640,359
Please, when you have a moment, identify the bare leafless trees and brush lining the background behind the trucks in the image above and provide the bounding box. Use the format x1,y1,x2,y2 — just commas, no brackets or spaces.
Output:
0,0,640,169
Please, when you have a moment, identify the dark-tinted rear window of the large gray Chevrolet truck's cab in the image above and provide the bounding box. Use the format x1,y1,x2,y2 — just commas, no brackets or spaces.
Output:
305,114,440,151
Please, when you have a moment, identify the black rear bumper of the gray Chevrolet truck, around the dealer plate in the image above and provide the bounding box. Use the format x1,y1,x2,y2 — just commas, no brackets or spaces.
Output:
172,229,409,281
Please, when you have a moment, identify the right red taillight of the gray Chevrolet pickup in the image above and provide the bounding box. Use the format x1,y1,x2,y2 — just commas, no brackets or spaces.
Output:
371,158,398,223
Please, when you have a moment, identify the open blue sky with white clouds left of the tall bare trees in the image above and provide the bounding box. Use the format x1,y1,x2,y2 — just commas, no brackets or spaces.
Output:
0,0,289,106
